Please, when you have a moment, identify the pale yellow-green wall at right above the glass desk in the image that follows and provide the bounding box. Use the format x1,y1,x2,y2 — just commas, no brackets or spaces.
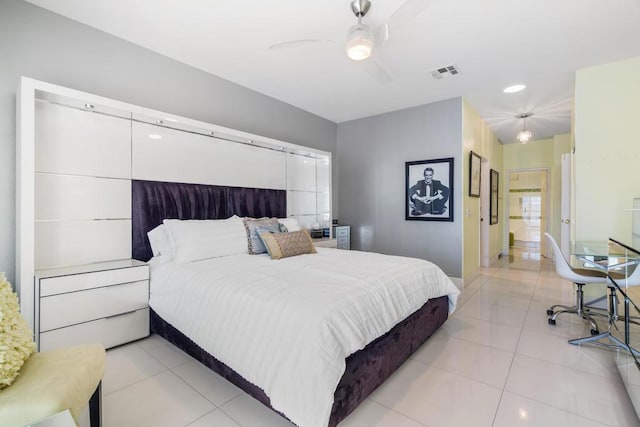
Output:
573,57,640,241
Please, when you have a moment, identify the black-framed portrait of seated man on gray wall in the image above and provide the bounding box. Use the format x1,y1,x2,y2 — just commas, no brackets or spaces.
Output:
404,157,454,222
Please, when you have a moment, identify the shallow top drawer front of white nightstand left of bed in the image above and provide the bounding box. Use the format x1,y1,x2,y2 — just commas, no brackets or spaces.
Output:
40,265,149,297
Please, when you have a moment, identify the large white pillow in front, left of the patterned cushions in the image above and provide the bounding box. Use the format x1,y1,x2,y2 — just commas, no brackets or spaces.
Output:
164,215,249,263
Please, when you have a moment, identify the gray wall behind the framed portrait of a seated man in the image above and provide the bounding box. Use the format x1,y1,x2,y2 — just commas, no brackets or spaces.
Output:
338,98,463,277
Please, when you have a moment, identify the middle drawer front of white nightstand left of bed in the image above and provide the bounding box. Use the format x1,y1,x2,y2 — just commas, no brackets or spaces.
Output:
40,280,149,331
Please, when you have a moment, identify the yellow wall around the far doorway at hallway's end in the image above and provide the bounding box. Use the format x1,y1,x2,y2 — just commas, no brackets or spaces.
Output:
503,134,571,251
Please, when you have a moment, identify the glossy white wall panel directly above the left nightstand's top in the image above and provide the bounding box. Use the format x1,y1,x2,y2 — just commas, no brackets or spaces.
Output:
35,219,131,269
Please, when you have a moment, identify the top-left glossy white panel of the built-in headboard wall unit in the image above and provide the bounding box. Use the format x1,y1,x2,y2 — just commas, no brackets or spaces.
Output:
35,102,131,178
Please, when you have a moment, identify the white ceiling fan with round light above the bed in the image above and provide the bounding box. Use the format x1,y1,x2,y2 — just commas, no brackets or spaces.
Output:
269,0,433,83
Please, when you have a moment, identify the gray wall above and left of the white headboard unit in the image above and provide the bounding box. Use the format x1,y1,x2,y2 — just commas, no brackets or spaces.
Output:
0,0,337,281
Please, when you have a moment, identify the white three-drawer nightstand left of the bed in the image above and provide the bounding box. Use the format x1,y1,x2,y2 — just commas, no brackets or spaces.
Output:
34,259,149,351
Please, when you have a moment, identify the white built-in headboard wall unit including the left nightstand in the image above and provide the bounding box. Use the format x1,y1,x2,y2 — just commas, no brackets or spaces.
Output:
16,78,331,348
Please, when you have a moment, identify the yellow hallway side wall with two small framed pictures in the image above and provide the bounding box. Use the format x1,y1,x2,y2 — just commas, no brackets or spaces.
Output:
462,100,505,282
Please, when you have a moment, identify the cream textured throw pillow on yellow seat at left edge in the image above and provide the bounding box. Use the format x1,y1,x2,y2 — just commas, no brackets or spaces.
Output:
0,273,36,390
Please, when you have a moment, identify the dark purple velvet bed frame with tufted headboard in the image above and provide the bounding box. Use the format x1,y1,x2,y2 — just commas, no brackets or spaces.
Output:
132,180,449,427
